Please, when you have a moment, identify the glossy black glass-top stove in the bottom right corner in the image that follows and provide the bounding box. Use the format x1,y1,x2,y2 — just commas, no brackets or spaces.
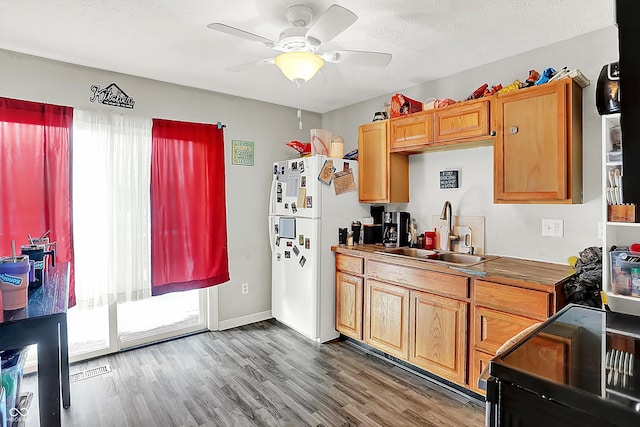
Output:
486,305,640,427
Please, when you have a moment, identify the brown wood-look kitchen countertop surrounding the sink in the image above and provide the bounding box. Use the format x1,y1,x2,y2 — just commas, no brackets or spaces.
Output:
331,245,575,291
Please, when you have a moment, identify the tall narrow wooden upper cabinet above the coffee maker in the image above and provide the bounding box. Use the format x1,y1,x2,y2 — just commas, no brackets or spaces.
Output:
358,120,409,203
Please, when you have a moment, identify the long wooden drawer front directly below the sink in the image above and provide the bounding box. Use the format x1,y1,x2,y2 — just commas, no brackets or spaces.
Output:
367,260,469,298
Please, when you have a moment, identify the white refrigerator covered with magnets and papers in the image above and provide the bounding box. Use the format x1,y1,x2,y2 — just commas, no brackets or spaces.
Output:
269,156,368,342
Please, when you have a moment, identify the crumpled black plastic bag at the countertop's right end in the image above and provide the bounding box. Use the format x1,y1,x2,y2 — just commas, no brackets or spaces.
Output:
563,246,602,307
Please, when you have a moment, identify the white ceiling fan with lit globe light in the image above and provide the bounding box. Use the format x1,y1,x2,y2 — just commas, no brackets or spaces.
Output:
207,4,391,85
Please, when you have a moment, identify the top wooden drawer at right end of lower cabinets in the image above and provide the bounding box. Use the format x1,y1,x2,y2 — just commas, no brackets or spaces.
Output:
475,280,551,320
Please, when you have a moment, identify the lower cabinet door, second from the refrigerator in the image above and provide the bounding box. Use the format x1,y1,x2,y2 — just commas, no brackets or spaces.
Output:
364,280,409,360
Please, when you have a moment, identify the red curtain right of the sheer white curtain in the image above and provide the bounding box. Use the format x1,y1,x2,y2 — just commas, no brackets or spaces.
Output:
151,119,229,295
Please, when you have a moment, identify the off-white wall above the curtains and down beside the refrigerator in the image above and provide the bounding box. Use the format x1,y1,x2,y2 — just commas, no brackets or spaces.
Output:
0,50,320,322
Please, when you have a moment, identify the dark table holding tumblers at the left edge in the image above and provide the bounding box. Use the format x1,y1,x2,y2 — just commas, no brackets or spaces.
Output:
0,263,71,427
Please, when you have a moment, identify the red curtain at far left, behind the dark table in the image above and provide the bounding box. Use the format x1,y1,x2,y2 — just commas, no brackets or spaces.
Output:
0,98,75,307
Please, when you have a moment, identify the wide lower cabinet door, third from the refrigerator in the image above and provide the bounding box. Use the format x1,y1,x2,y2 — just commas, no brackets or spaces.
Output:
409,291,468,384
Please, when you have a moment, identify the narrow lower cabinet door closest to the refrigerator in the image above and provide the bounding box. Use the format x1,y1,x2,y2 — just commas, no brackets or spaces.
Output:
336,272,364,340
